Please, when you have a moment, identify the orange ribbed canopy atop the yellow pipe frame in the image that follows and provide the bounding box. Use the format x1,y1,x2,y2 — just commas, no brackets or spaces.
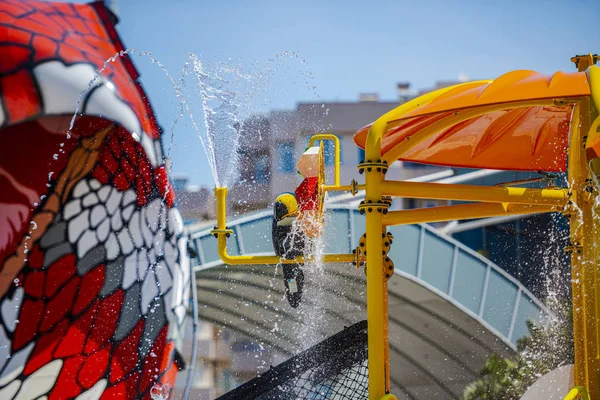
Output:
354,71,590,171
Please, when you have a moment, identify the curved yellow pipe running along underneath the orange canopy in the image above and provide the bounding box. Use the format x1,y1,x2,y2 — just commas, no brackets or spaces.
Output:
383,99,577,164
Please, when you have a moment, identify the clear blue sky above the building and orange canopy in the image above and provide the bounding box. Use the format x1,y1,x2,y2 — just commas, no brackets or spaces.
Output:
109,0,600,185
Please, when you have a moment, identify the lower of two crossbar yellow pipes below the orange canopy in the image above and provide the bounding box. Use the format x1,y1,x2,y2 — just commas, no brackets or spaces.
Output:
383,203,562,226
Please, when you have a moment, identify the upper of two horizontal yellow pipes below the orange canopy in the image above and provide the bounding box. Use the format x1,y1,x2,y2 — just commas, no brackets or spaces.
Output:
382,181,568,207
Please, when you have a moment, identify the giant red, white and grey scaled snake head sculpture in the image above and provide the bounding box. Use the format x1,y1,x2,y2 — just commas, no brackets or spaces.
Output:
0,0,190,399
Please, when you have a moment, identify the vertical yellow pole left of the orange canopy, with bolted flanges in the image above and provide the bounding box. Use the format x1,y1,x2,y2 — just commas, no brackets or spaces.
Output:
365,122,387,400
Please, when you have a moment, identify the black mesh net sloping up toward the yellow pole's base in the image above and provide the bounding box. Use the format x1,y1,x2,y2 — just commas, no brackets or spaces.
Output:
219,321,369,400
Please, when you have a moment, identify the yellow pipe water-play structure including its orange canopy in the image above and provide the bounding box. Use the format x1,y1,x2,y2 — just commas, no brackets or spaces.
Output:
207,54,600,399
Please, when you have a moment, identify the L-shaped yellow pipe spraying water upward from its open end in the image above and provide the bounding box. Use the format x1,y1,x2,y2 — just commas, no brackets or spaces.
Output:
215,188,355,265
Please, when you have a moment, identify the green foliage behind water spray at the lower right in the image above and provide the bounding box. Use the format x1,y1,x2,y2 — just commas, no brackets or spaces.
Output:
463,304,574,400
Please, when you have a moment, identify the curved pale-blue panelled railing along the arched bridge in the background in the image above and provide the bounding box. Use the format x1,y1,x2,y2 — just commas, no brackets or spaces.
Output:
190,205,550,349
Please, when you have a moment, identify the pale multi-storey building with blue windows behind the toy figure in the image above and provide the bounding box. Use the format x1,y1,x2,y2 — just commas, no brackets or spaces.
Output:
230,92,446,212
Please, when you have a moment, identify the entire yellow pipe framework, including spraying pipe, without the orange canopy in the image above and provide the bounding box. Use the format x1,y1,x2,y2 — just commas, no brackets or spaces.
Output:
213,57,600,400
